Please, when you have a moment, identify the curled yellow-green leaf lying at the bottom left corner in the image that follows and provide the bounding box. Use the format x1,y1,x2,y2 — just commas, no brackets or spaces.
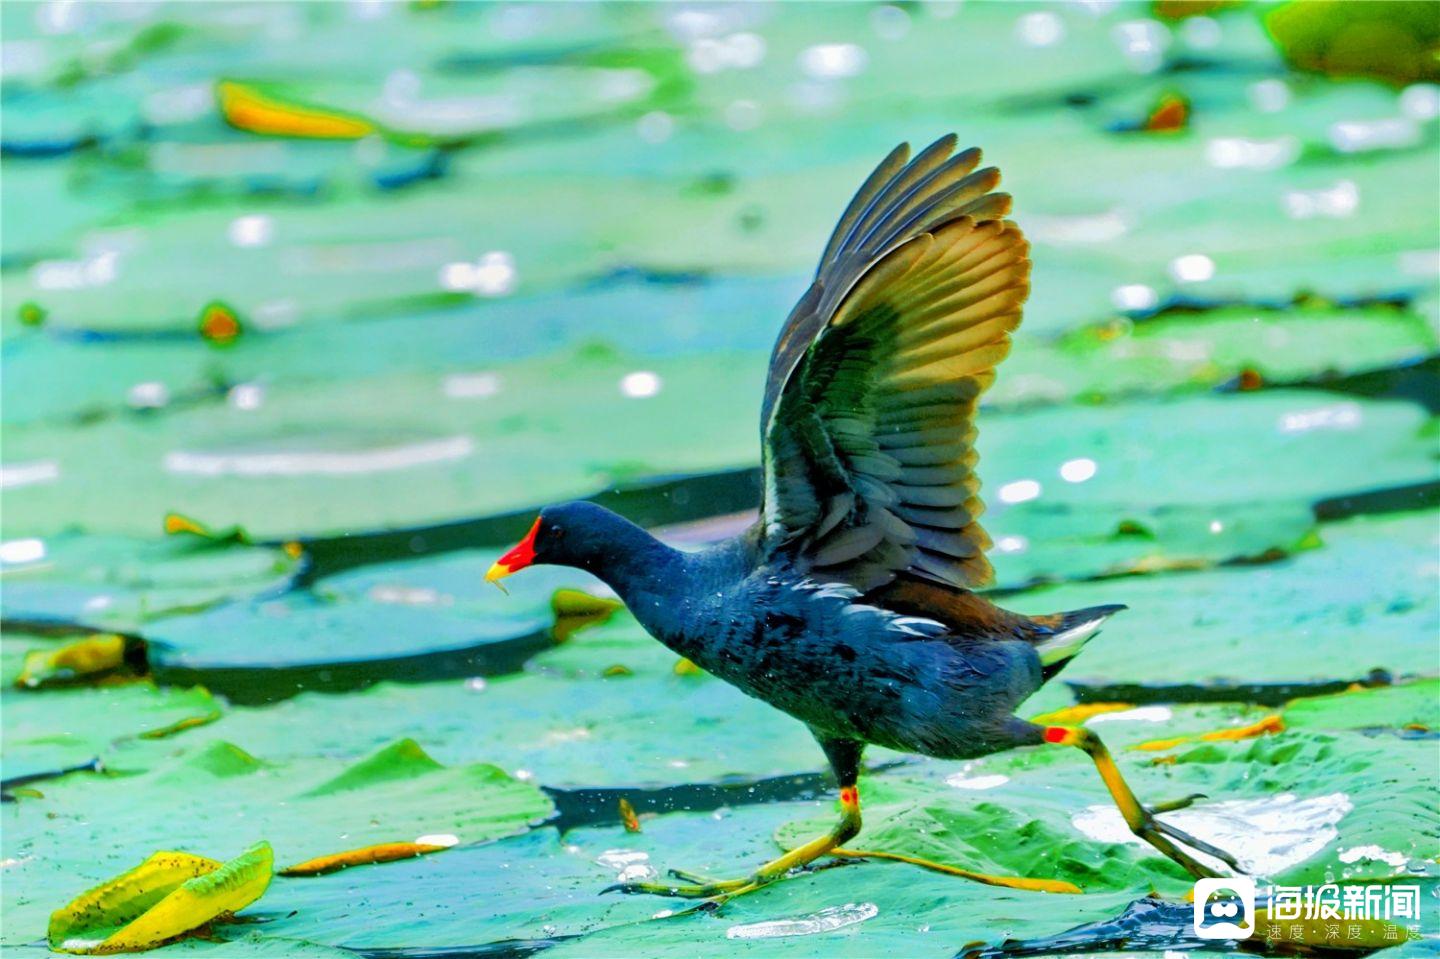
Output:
48,842,274,955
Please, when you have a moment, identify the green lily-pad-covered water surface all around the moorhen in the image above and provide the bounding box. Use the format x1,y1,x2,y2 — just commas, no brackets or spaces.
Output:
0,1,1440,956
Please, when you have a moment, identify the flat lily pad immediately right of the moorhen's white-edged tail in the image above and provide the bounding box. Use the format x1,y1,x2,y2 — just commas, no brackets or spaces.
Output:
1004,513,1440,688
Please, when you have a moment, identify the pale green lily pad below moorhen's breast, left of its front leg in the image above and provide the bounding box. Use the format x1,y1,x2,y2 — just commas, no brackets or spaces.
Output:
187,607,846,802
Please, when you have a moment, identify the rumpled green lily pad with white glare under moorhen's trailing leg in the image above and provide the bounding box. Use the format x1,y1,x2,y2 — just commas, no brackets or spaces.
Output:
778,727,1440,894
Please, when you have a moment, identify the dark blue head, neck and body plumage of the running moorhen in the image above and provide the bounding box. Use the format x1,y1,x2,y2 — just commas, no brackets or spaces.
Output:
531,503,1117,759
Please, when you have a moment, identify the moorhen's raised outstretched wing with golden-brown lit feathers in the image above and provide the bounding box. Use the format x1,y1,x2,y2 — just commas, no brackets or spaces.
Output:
762,135,1030,590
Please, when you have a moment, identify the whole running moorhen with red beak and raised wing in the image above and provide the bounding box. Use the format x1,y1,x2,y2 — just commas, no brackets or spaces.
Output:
487,134,1238,901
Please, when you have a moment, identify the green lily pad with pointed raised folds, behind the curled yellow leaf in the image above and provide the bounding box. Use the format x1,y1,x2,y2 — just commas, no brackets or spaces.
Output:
4,740,554,942
